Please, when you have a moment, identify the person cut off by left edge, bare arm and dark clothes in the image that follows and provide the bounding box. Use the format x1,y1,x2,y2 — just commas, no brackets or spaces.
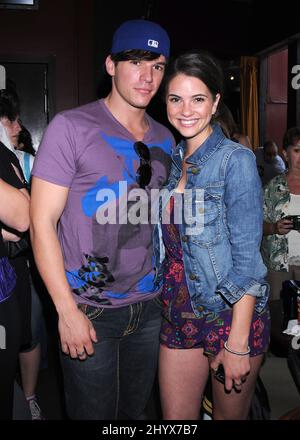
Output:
0,90,30,420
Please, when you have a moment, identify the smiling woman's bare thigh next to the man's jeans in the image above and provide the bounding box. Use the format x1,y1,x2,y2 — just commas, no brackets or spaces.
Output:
159,345,209,420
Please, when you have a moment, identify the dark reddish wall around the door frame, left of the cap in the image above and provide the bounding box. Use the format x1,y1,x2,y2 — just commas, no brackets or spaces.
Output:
0,0,95,111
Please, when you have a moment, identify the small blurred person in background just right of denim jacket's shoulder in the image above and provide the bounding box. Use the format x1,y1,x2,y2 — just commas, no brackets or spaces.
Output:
255,141,285,186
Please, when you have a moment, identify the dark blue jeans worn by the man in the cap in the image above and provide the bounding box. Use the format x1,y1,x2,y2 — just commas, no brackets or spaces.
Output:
62,298,162,420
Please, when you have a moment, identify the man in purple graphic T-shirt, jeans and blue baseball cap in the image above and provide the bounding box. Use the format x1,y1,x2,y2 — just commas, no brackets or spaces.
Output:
31,20,174,419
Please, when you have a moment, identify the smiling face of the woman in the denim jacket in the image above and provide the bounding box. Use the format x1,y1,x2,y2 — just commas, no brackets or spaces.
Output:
166,73,220,150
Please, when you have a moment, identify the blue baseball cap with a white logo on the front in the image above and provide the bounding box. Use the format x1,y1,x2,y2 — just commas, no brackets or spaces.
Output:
110,20,170,58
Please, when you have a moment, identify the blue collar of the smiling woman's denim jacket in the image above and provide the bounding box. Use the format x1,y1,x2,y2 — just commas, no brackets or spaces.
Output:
172,124,225,170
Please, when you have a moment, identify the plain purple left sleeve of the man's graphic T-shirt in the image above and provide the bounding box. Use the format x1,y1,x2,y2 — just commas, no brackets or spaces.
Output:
32,113,76,188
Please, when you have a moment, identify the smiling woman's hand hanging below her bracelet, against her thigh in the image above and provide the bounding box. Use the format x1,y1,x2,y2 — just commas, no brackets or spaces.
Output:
210,348,250,391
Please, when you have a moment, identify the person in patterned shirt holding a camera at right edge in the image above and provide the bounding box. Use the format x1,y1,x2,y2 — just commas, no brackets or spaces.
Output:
262,127,300,300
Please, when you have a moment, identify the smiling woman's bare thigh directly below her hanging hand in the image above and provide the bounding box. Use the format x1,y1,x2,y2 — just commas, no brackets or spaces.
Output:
212,354,264,420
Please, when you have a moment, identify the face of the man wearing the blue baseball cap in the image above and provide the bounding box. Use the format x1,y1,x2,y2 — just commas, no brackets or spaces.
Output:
106,55,166,109
